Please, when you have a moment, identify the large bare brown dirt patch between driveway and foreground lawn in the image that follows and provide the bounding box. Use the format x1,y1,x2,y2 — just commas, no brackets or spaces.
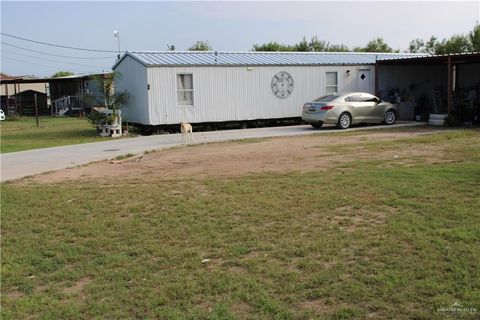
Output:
22,128,442,183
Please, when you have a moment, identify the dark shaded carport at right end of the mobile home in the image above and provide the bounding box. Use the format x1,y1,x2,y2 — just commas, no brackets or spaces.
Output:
375,52,480,121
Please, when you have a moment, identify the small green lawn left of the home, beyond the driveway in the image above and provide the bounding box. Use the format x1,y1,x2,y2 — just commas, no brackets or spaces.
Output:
0,117,108,153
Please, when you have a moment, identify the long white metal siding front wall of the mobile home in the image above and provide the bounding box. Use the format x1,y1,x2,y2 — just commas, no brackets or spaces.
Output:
147,66,374,124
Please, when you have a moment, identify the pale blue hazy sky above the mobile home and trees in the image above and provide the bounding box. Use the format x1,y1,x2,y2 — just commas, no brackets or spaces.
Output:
0,0,480,77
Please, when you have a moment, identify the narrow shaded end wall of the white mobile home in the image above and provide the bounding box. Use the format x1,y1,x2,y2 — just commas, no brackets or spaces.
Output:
114,57,151,124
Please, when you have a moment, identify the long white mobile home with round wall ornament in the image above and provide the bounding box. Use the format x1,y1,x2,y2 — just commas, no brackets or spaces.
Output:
113,51,420,126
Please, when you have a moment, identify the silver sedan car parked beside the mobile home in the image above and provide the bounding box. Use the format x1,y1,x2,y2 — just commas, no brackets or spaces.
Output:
302,92,398,129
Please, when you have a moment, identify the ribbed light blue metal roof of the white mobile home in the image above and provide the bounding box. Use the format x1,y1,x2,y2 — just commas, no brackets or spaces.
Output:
112,51,425,69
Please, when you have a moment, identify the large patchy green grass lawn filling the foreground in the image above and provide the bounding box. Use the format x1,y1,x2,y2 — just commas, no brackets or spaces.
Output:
1,129,480,319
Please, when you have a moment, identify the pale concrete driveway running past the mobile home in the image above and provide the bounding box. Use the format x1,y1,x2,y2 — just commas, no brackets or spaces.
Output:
0,122,425,182
